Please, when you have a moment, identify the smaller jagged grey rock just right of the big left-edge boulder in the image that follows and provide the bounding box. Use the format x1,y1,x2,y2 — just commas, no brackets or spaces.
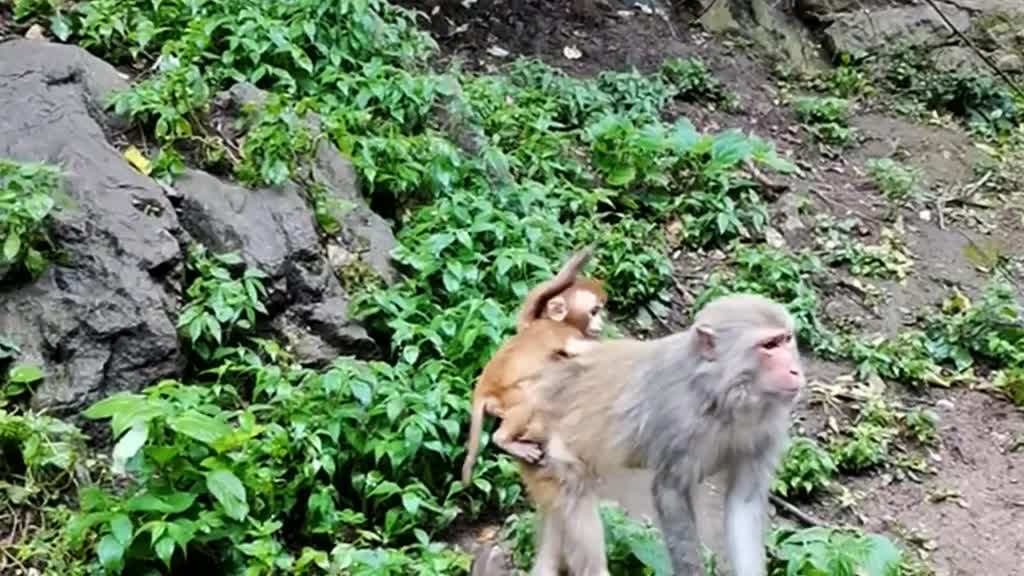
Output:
174,170,379,366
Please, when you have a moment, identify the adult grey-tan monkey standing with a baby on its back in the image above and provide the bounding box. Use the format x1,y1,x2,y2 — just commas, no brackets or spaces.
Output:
523,294,804,576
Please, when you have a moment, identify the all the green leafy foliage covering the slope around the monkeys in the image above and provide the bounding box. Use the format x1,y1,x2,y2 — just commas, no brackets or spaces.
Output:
0,0,1024,576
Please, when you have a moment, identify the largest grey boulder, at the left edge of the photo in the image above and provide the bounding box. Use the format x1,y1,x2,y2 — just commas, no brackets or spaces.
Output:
0,39,183,414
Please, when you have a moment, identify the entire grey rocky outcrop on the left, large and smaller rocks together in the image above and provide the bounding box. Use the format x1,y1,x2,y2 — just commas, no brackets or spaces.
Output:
0,39,395,412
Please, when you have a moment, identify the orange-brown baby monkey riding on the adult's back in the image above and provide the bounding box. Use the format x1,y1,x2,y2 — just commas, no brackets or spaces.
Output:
462,246,608,484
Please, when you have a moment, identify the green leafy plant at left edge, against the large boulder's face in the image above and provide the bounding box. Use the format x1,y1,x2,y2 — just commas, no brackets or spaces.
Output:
0,159,60,280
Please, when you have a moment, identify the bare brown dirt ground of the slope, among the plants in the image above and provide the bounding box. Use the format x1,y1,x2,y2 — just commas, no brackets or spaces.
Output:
405,0,1024,576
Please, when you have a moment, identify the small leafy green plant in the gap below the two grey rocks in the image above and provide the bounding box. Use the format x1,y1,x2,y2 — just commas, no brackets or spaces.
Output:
177,244,266,361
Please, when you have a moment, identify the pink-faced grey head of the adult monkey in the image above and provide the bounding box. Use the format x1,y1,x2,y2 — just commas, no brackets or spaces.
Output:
692,294,805,404
